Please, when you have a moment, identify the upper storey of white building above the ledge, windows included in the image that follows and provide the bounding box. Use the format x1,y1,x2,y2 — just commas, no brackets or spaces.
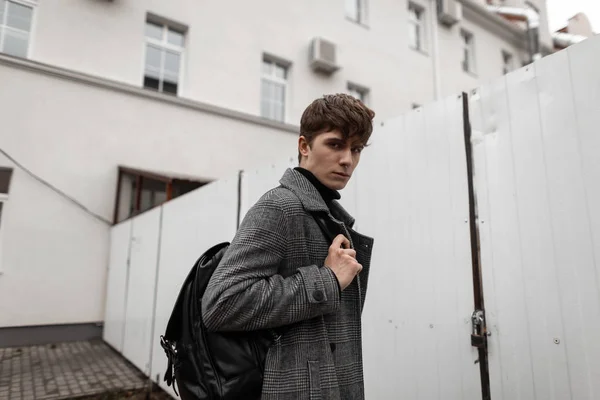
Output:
2,0,552,124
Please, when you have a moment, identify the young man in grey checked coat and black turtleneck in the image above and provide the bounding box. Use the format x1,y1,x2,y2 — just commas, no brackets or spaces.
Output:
202,94,375,400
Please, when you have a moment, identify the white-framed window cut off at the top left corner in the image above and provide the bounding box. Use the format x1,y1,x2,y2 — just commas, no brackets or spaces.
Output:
0,0,33,57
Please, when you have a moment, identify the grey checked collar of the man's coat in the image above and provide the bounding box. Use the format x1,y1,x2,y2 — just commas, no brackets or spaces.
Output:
279,168,354,227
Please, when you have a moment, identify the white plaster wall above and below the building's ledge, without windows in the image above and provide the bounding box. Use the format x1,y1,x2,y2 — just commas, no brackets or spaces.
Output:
0,0,552,327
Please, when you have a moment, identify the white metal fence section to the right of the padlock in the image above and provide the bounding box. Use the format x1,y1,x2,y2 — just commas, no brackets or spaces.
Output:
470,36,600,400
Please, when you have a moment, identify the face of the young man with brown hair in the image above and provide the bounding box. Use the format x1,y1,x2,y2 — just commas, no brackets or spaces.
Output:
298,130,364,190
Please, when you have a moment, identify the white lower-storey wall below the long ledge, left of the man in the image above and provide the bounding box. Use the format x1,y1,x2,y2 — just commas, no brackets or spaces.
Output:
0,59,297,327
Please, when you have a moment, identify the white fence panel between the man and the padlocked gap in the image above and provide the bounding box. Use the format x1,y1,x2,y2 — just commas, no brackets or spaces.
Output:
356,96,481,399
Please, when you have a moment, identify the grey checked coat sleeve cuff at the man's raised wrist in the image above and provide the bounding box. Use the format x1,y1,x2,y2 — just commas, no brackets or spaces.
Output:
298,265,341,314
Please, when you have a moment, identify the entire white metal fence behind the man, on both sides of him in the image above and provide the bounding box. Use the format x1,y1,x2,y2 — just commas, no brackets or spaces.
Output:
104,37,600,400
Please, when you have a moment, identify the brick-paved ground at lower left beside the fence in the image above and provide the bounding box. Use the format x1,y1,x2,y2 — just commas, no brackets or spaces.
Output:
0,340,146,400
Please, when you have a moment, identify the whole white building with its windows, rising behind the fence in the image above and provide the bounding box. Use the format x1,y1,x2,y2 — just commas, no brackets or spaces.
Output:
0,0,552,339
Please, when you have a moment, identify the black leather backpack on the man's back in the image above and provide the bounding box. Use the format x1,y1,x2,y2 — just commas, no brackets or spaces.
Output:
160,215,333,400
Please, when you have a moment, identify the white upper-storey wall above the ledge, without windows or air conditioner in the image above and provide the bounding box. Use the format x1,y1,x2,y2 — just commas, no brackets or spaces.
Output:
31,0,536,123
